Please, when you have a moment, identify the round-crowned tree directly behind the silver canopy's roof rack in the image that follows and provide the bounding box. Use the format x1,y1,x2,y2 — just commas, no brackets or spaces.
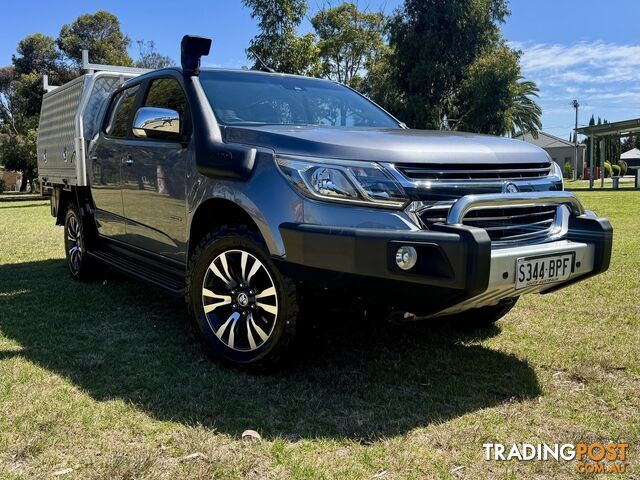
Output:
57,10,133,69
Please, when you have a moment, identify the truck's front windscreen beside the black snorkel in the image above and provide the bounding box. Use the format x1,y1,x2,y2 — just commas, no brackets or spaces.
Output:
200,71,399,128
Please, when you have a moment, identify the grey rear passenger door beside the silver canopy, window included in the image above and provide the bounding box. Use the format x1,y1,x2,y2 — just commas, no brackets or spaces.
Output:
90,85,139,239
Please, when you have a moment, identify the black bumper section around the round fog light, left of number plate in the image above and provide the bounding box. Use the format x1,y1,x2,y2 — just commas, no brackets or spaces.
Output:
280,223,491,296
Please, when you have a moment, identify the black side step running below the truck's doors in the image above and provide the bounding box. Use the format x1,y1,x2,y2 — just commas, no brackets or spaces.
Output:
87,242,185,296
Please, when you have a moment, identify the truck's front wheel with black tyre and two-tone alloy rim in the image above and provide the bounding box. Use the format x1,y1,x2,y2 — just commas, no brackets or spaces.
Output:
187,227,298,369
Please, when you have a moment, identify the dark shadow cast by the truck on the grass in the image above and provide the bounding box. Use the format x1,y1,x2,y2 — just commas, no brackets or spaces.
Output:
0,260,540,442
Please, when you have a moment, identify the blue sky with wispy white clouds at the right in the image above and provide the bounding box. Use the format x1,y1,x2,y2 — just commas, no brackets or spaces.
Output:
0,0,640,138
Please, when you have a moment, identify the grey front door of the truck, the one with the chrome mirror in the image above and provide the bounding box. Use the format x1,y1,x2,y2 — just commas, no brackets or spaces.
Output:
122,76,191,261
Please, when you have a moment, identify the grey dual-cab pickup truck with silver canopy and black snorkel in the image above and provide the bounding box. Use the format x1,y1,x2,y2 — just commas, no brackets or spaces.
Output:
38,36,612,368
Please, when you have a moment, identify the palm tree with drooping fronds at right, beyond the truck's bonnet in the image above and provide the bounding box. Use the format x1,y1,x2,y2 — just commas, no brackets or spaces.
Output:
505,77,542,138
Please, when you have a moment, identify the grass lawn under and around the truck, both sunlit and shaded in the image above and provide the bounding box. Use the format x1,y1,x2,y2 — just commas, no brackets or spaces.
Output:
0,192,640,480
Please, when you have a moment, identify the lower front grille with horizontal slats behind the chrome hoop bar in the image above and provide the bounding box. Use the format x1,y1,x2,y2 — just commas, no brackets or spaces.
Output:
417,203,558,242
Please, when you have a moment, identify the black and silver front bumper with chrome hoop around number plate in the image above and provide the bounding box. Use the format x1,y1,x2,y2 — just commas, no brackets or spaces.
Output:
280,194,613,315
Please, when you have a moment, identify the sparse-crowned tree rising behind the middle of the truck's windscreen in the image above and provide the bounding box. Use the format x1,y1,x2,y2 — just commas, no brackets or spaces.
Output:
311,3,387,88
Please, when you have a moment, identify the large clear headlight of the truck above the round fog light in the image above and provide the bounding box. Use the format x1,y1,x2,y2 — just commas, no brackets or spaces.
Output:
276,156,409,208
